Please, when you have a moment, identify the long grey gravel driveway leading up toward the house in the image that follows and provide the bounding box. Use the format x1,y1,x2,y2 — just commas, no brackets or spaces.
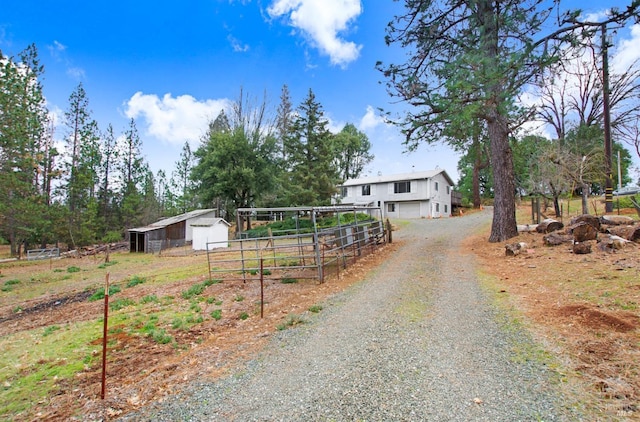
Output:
123,210,580,421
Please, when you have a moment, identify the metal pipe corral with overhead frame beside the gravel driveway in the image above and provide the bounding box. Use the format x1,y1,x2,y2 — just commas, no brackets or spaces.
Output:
207,206,390,282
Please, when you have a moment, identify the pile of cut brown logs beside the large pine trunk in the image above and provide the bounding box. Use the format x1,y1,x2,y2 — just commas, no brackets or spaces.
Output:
507,214,640,255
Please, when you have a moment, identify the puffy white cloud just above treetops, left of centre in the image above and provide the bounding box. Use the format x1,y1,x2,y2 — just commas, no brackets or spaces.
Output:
125,92,231,144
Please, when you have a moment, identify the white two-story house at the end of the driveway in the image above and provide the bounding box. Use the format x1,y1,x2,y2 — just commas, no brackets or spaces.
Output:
340,169,453,218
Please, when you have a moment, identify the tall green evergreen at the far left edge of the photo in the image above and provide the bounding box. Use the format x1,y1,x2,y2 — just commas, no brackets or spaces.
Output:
0,45,47,255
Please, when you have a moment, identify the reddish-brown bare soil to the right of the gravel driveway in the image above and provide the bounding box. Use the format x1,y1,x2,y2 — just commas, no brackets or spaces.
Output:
464,214,640,420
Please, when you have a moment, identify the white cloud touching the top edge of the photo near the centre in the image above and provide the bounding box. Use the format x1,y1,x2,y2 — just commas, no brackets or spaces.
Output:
267,0,362,67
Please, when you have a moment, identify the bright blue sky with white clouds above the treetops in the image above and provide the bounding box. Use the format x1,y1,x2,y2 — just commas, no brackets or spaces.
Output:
0,0,640,185
